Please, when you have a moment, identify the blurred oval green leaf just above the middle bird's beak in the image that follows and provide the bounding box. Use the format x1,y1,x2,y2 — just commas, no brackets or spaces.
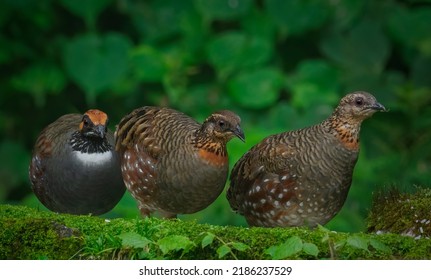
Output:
229,68,283,109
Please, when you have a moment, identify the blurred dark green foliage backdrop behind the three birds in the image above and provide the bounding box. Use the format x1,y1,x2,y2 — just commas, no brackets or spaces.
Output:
0,0,431,231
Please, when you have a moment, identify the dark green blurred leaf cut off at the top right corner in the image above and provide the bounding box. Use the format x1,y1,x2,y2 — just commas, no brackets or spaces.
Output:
388,7,431,57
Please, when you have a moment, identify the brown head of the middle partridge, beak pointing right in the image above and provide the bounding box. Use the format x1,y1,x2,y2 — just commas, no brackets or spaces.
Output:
202,110,245,142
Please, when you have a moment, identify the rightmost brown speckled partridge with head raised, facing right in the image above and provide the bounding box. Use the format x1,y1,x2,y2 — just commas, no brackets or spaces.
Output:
227,92,385,227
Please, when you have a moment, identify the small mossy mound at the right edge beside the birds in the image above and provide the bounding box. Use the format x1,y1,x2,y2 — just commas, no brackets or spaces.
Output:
368,188,431,239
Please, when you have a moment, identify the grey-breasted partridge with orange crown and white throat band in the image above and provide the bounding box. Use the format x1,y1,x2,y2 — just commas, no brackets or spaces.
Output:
29,110,126,215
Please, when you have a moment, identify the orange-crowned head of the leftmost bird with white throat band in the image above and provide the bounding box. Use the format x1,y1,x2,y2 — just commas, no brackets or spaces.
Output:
79,109,109,139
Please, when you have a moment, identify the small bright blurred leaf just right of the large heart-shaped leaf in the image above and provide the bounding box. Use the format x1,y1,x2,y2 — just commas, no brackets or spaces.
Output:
131,45,167,82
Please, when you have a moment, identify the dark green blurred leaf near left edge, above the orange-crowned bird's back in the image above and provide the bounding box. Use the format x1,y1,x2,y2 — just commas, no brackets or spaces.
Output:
12,63,66,107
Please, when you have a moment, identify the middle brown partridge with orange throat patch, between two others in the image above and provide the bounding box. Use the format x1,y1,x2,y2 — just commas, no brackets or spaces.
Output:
116,106,244,217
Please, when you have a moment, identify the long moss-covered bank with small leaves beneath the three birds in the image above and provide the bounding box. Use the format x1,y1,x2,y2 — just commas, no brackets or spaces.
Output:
0,205,431,259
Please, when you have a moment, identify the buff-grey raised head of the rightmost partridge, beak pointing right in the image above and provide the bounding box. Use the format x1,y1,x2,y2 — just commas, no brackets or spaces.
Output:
335,91,386,122
